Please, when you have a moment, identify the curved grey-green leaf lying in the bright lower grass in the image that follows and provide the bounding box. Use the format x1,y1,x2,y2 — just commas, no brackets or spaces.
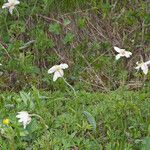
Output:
83,111,96,131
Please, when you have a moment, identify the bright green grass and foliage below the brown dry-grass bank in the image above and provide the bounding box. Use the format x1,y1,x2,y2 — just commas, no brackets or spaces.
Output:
0,88,150,150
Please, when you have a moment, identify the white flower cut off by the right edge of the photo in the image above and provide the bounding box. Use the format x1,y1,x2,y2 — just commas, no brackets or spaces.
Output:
135,60,150,75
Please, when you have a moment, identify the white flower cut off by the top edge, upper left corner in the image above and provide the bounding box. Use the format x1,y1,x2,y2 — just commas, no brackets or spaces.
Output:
2,0,20,14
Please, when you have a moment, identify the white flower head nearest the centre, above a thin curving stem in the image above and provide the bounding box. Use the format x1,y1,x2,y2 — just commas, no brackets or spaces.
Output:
48,64,68,81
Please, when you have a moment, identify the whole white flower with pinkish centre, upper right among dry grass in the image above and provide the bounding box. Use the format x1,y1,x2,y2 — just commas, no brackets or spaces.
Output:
114,46,132,60
